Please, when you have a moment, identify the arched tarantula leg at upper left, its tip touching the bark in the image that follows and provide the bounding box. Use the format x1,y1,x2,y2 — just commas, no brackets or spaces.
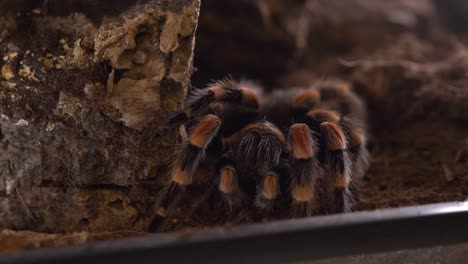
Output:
165,80,260,127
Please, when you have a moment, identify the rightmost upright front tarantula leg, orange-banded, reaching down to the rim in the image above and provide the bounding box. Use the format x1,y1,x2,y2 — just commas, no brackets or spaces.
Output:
320,122,352,213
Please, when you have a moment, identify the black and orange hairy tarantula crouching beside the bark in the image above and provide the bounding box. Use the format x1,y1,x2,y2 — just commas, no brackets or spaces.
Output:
150,79,368,228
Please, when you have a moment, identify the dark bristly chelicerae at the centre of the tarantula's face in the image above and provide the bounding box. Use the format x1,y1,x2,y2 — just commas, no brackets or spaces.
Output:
236,121,286,172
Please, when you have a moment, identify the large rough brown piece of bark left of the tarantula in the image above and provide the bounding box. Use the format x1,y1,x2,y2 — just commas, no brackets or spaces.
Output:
0,0,200,232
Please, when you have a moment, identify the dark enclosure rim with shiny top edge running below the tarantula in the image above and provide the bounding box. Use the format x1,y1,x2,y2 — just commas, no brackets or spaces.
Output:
0,201,468,263
